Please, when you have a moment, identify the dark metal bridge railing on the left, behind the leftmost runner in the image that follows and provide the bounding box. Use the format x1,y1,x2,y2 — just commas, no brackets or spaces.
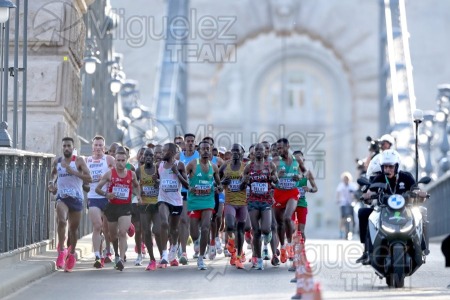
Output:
0,148,92,253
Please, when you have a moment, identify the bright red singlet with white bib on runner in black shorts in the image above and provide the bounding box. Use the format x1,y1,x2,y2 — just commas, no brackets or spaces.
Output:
108,168,133,205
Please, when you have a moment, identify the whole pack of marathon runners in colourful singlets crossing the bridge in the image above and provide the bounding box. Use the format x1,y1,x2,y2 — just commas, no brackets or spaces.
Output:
48,134,318,272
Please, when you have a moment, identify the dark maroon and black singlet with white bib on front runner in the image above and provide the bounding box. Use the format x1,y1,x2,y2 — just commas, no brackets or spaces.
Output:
248,161,273,205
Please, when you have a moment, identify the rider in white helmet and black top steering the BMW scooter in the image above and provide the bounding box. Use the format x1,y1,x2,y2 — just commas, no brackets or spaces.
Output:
356,149,429,264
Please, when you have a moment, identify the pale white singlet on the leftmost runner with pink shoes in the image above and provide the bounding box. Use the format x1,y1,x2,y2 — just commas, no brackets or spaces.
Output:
56,155,83,201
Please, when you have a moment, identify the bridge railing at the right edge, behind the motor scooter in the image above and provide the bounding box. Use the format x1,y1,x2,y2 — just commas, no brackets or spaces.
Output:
425,172,450,237
